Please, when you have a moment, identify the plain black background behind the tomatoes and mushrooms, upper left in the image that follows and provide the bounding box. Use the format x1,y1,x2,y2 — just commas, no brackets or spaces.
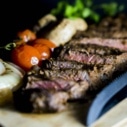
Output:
0,0,127,45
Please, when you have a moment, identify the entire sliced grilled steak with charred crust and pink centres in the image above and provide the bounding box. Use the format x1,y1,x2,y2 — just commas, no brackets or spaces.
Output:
14,15,127,113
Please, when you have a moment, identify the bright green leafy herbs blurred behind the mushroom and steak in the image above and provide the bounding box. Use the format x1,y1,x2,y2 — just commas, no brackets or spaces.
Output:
51,0,124,22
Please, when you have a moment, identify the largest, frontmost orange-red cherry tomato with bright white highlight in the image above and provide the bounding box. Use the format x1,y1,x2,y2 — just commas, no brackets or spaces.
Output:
11,44,41,71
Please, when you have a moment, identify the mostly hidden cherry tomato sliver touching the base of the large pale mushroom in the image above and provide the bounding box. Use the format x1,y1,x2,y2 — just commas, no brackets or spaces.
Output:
32,38,56,50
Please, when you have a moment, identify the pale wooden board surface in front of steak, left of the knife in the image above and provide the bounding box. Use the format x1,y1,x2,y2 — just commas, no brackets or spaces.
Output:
0,102,88,127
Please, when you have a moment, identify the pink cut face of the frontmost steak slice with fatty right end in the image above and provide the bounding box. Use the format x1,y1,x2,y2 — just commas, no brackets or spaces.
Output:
24,78,89,99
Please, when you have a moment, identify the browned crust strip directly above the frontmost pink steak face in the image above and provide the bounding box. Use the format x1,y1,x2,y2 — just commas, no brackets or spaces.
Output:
26,64,89,82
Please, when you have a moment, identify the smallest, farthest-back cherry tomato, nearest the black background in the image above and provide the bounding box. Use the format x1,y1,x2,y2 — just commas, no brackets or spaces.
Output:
17,29,36,42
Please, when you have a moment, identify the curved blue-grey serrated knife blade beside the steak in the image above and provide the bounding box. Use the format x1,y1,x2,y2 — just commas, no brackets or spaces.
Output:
86,72,127,126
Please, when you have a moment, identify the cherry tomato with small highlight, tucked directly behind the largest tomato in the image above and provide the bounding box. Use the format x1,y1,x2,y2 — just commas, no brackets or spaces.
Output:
32,43,51,60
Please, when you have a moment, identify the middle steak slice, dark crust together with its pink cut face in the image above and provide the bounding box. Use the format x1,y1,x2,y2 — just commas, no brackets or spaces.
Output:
53,44,122,65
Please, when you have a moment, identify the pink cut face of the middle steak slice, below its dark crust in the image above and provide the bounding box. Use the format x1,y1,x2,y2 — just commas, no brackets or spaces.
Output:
59,50,116,65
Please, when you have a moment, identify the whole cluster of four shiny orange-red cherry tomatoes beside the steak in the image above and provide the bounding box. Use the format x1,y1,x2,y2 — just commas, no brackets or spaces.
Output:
11,32,56,71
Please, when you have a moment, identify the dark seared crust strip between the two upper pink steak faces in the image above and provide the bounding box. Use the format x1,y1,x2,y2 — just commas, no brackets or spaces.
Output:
53,43,123,59
